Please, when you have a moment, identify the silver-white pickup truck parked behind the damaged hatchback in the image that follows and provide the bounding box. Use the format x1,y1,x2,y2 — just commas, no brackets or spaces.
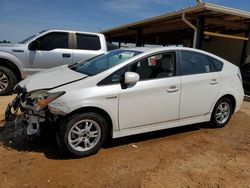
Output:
0,30,113,96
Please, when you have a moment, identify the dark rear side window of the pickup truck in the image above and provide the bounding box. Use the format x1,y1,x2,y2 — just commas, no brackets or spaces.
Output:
76,33,101,50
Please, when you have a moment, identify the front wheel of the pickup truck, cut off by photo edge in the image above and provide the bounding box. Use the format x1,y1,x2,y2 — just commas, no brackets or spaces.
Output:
0,66,18,96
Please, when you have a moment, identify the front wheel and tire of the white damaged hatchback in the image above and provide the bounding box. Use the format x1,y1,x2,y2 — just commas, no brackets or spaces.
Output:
57,112,109,157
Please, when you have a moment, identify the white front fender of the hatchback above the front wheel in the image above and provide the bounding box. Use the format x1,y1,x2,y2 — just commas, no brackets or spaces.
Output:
49,81,120,130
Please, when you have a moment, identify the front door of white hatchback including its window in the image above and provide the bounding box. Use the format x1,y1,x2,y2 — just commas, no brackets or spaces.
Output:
119,52,180,129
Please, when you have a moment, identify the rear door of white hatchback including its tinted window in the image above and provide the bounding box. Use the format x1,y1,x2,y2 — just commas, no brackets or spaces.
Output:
180,50,221,119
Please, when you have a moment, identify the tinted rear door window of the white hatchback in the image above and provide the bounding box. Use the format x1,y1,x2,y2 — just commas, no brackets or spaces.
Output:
180,51,213,75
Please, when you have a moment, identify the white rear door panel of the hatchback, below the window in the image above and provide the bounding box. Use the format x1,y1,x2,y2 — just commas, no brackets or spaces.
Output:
179,72,221,119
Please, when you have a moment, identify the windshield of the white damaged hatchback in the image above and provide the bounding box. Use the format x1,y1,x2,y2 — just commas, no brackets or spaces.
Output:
70,50,141,76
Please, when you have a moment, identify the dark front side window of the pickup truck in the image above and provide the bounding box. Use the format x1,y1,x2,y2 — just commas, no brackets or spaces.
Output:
38,32,69,51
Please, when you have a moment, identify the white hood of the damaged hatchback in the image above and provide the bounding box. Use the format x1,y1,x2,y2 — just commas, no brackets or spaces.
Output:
19,65,87,92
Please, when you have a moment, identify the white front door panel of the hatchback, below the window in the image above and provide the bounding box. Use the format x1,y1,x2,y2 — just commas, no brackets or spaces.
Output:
119,77,180,129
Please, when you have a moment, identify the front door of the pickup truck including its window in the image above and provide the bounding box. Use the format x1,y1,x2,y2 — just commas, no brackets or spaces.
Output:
27,32,72,73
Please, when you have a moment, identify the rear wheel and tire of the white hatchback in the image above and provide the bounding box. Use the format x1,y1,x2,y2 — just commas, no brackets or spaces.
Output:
211,98,233,128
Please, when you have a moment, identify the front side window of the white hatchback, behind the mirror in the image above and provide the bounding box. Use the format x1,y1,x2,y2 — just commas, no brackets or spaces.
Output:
131,53,175,80
